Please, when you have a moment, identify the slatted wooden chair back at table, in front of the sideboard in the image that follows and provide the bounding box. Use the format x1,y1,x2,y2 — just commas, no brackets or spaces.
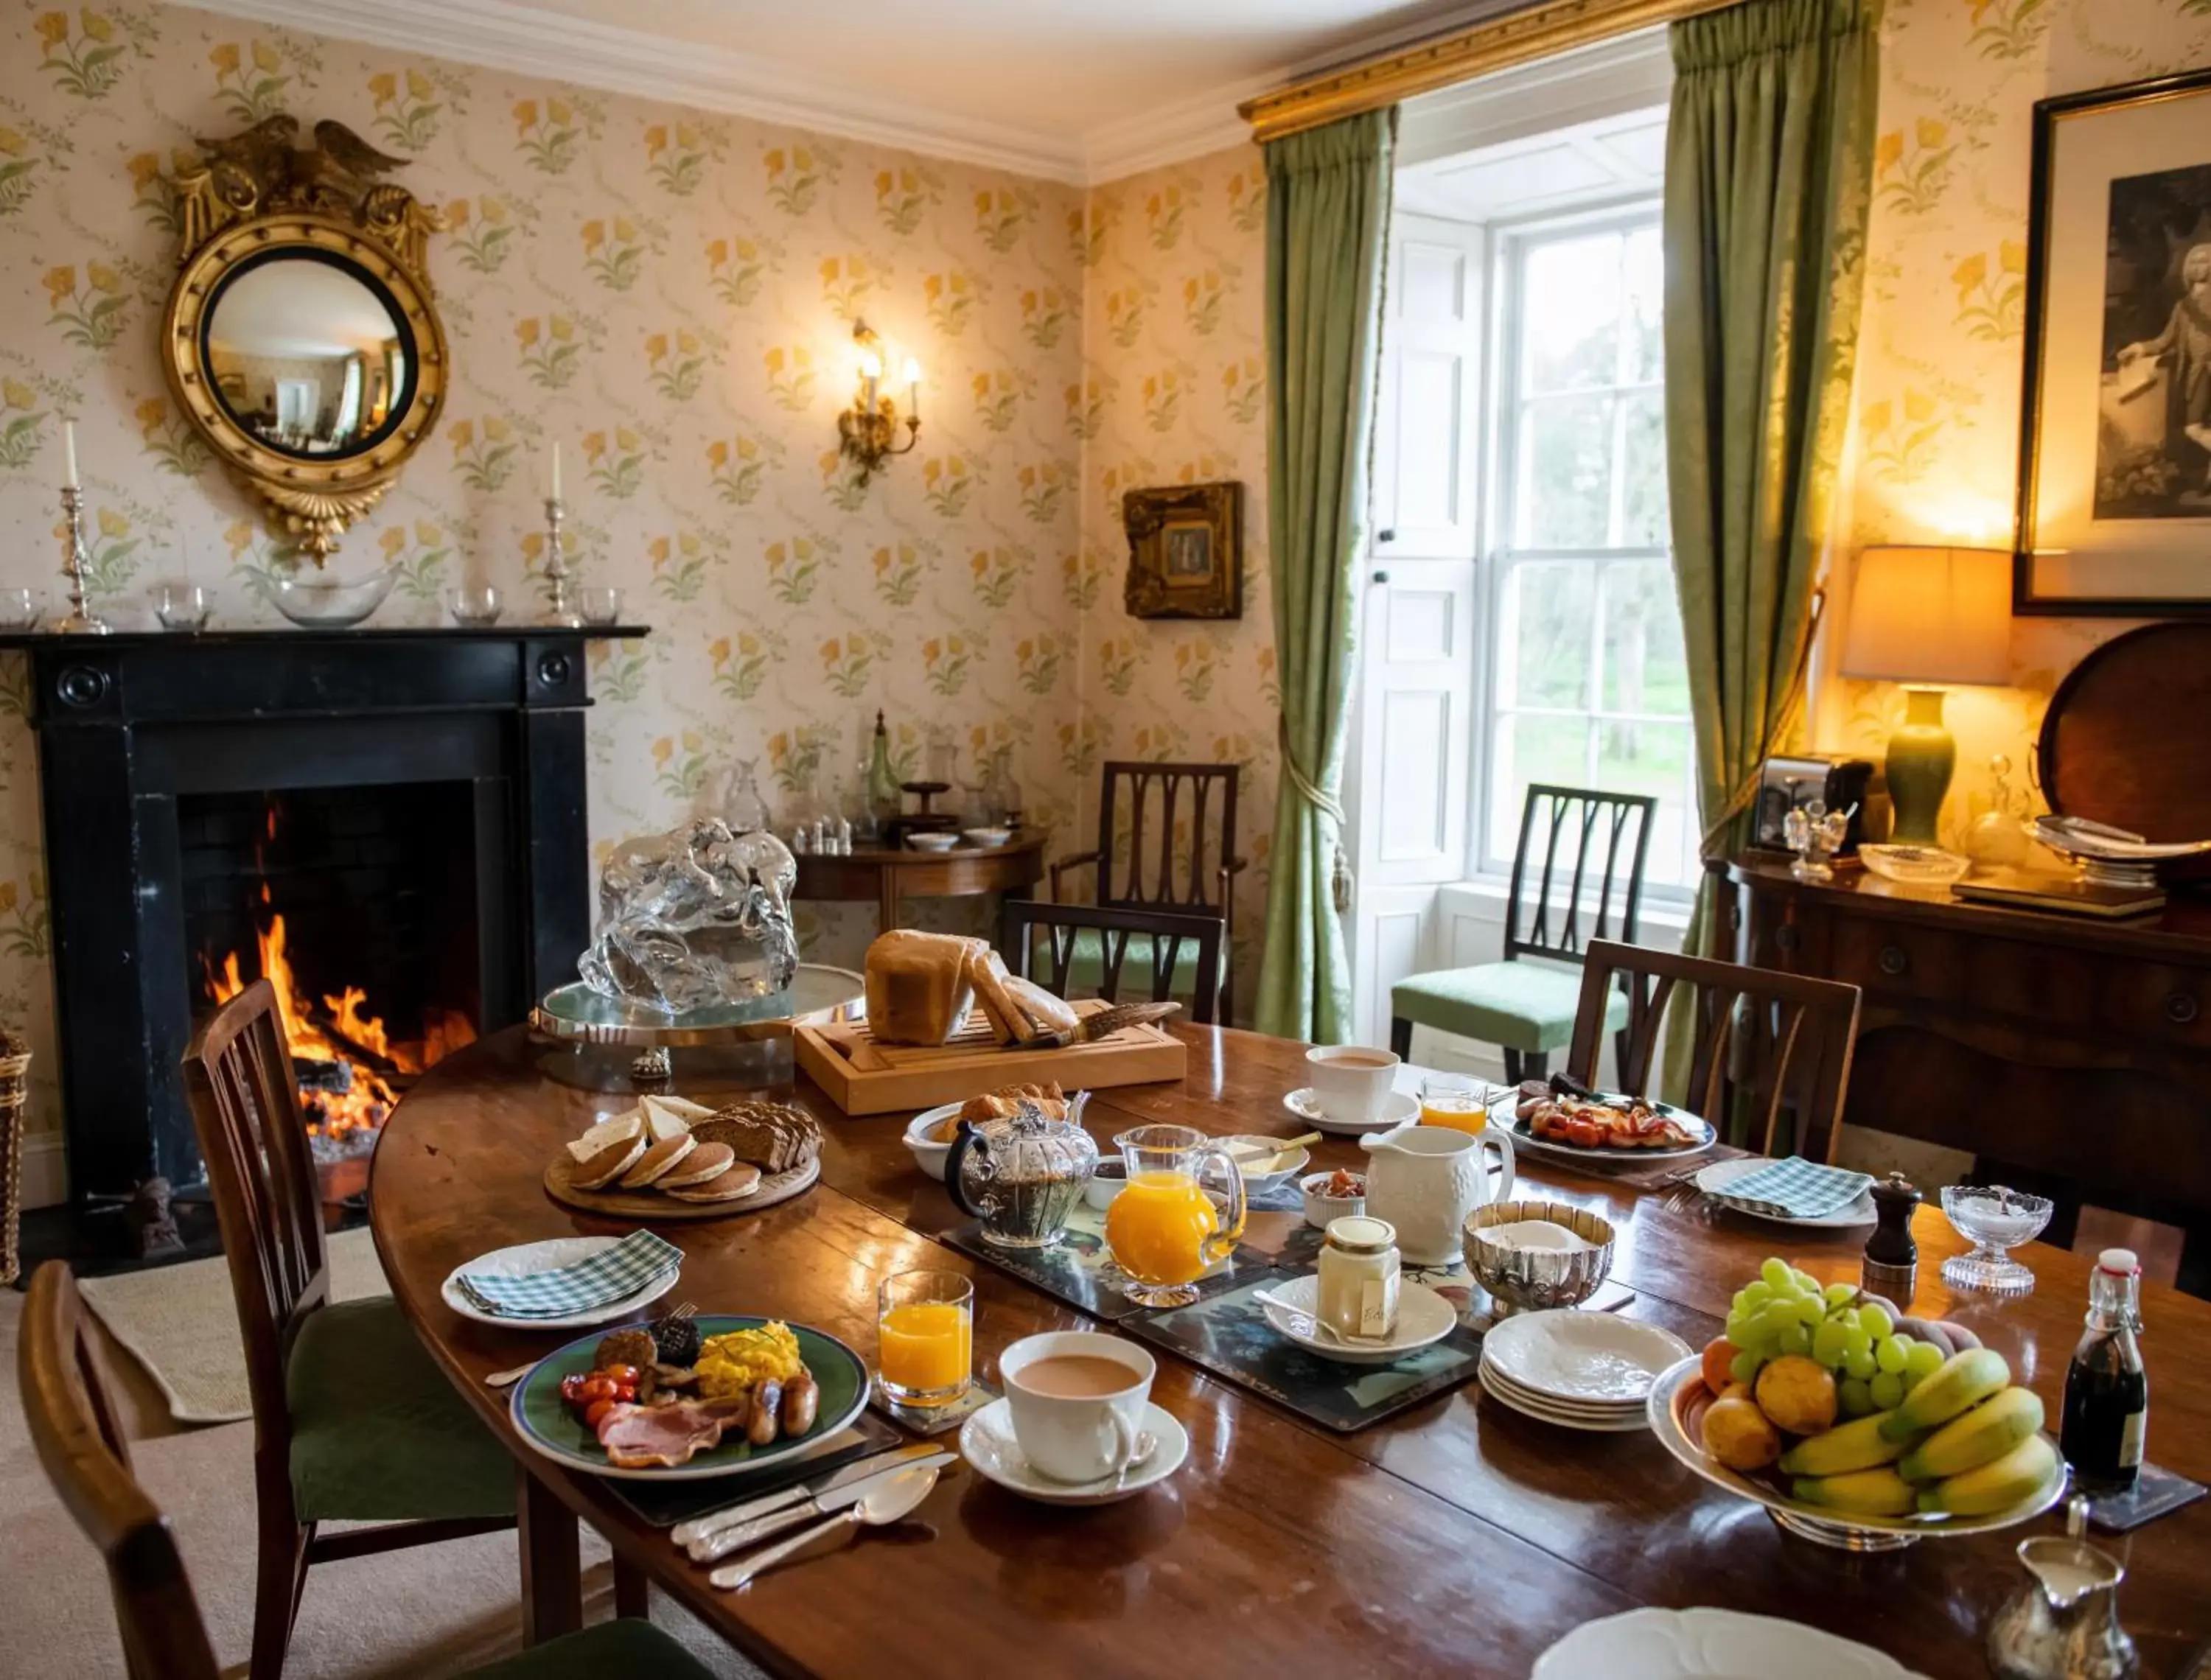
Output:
1568,939,1857,1161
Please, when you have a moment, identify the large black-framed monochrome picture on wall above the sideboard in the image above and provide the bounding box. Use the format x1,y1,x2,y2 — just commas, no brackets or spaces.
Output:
2012,69,2211,617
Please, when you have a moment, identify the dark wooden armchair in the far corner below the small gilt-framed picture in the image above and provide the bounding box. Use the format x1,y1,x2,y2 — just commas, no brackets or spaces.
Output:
1052,758,1249,1021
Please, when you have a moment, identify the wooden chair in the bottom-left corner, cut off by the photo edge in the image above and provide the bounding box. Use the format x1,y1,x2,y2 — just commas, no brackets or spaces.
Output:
15,1260,710,1680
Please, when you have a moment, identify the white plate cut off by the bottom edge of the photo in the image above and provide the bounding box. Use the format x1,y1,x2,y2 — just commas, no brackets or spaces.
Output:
1530,1609,1921,1680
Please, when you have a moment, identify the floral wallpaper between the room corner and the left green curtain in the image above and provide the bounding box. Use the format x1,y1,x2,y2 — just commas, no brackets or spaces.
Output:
1061,146,1278,1019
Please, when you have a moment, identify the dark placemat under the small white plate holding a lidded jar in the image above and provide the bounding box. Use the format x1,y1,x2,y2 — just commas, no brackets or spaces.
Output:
1123,1269,1481,1435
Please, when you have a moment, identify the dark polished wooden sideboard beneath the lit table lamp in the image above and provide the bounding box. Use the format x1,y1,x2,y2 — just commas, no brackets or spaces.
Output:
1722,858,2211,1295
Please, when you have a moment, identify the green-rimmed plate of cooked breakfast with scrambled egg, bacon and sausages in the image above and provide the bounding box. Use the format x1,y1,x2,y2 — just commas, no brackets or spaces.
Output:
509,1311,867,1481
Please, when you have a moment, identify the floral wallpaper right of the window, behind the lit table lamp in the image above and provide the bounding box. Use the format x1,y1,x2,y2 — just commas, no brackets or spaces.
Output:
1817,0,2211,844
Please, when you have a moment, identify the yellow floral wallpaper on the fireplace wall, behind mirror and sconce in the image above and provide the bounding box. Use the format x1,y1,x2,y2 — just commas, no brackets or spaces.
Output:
0,0,1097,1127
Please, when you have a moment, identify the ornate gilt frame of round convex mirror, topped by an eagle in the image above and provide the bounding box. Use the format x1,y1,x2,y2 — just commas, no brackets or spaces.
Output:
161,115,451,566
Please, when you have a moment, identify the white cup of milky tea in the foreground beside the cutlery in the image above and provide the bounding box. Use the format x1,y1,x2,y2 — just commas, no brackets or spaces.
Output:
997,1331,1159,1481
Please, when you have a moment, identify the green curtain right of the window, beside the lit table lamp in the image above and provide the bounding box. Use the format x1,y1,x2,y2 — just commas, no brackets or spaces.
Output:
1665,0,1879,977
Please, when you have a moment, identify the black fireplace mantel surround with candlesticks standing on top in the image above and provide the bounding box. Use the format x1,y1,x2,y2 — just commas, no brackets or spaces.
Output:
0,626,646,1207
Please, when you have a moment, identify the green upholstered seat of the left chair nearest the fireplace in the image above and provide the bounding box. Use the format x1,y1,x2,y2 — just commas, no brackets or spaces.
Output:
285,1295,515,1523
